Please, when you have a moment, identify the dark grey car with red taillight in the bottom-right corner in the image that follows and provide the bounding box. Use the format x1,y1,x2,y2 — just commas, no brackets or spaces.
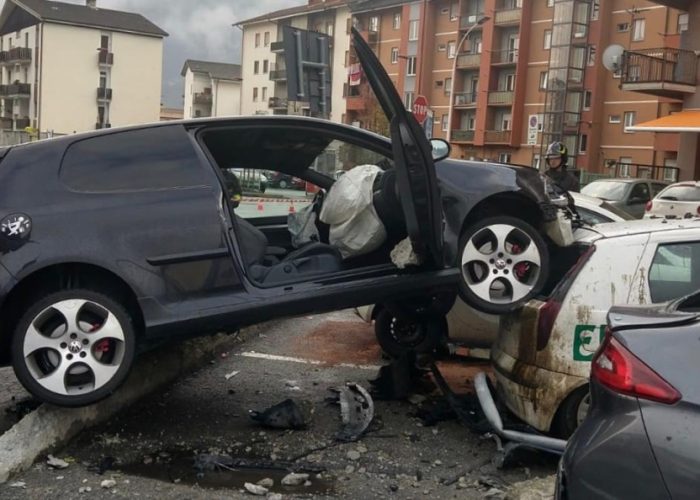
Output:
556,293,700,499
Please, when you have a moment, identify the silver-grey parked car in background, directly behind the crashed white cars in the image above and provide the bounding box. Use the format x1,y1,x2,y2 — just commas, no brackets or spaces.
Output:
581,178,668,219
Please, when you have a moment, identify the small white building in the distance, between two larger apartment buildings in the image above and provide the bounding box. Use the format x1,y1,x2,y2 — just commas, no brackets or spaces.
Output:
181,59,242,118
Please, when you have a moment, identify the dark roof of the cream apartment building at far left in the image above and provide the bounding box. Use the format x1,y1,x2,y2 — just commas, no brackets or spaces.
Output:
11,0,168,37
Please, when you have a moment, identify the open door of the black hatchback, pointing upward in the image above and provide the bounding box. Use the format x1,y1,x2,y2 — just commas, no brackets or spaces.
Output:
352,28,443,267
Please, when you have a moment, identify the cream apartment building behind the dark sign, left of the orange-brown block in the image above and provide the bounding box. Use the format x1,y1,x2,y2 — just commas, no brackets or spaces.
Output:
236,0,350,122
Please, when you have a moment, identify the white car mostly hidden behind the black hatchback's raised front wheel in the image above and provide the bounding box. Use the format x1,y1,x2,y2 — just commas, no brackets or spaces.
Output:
357,193,633,357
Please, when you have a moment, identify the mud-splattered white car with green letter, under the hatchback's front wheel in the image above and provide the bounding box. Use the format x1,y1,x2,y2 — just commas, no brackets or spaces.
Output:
491,219,700,437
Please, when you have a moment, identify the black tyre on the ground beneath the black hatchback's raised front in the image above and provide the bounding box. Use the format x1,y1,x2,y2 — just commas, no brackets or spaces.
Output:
374,309,447,358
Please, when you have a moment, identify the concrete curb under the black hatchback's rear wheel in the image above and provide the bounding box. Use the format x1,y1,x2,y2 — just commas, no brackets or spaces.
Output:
0,325,261,484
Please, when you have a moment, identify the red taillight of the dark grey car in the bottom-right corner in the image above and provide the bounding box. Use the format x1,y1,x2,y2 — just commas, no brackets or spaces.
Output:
591,333,681,404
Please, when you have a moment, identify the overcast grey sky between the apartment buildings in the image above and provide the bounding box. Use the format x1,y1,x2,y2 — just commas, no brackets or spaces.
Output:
64,0,307,108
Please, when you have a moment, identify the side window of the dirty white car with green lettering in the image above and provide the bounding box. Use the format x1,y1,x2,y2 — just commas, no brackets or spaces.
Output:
649,242,700,303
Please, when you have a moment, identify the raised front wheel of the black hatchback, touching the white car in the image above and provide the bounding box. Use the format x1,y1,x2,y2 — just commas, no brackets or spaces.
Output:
458,215,549,314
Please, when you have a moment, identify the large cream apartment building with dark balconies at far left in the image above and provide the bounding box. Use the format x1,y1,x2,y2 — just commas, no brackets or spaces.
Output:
0,0,168,134
